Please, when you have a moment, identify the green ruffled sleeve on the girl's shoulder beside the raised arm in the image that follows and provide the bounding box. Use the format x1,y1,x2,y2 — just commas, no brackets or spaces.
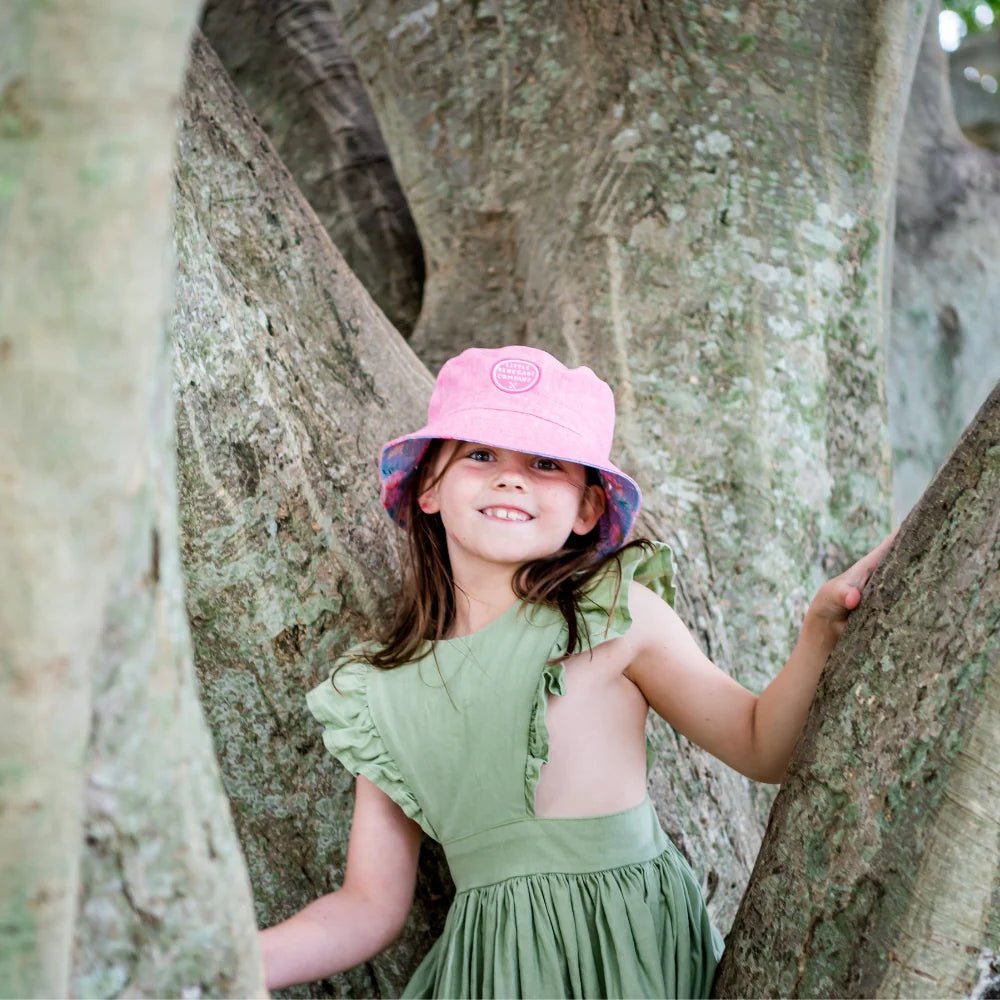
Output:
580,542,676,646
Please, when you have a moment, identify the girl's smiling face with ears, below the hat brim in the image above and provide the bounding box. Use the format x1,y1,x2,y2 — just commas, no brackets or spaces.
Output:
418,441,605,576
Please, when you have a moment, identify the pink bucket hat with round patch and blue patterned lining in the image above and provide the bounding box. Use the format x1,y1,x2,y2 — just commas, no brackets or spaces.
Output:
379,347,642,554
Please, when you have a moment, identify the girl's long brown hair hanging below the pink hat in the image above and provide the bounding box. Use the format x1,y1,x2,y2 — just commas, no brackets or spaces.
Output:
357,440,648,670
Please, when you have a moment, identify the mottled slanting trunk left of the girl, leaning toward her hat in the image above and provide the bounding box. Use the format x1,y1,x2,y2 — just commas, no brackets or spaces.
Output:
173,40,449,996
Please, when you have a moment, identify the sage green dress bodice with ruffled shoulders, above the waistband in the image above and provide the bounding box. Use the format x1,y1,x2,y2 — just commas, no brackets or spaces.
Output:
308,545,673,844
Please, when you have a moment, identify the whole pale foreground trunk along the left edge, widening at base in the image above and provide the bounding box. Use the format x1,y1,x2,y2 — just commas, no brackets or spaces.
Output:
0,0,261,997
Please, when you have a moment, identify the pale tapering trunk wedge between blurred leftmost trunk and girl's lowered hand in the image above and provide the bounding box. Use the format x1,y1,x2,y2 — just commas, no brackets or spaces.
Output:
71,316,266,997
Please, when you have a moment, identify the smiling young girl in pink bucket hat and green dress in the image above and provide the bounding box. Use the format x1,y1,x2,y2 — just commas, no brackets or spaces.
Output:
261,347,885,997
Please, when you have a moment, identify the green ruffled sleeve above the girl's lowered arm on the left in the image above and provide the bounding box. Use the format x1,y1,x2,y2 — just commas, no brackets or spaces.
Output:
306,660,434,836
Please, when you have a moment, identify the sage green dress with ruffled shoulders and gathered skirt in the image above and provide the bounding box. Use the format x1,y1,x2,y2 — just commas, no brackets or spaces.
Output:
308,546,722,997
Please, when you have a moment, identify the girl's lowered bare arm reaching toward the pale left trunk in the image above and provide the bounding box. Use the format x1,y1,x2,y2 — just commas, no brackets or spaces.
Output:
260,776,420,990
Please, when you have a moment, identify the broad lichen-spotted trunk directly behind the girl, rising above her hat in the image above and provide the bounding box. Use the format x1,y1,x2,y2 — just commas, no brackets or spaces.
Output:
334,0,926,927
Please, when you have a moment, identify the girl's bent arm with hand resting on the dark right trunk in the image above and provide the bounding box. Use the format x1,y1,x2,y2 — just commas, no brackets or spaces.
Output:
625,536,894,782
